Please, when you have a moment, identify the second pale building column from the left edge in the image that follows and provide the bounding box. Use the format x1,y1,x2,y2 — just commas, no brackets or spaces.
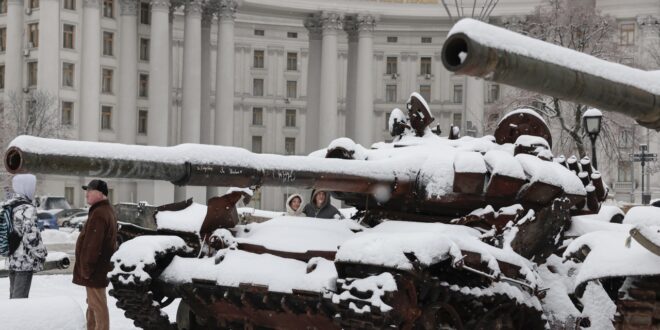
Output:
37,0,59,96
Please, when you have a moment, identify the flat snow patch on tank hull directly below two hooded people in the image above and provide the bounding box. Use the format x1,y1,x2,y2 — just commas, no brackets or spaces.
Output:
236,216,355,253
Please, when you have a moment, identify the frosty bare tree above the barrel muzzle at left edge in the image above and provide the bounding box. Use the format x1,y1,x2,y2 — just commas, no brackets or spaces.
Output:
0,90,70,150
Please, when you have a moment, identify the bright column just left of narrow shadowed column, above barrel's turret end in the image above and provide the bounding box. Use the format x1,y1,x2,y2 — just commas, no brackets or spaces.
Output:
319,12,342,146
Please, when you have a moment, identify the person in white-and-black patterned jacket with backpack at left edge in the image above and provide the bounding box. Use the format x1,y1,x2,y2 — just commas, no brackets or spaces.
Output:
2,174,48,299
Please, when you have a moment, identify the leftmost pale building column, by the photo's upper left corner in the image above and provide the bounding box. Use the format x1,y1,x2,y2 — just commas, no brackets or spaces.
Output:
5,0,25,103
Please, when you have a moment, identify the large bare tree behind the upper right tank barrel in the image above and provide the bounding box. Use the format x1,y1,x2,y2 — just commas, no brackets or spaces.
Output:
489,0,634,163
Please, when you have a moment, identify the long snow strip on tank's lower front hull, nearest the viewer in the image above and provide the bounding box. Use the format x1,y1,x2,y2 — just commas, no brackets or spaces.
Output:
161,249,337,293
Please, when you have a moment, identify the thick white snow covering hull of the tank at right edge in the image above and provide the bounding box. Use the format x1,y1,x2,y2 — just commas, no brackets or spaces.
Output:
564,231,660,285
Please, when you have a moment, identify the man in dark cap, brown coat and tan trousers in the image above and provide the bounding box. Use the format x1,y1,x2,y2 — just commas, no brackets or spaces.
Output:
73,180,117,330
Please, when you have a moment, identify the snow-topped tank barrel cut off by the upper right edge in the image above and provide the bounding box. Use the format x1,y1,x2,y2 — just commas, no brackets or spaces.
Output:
442,19,660,130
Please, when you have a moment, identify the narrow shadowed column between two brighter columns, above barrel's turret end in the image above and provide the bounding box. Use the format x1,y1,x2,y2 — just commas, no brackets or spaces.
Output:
343,16,361,140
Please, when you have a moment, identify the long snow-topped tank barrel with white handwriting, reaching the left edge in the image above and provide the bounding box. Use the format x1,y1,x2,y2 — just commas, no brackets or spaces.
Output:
4,136,410,193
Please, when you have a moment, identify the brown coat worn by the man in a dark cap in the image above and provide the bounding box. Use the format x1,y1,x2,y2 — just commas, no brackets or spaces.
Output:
73,200,117,288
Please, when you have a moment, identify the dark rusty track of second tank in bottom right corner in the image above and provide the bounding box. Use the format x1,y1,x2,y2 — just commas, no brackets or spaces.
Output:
614,275,660,330
